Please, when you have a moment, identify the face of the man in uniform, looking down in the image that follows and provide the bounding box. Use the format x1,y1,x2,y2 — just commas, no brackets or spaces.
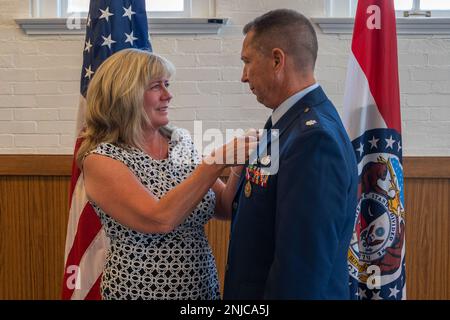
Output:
241,31,278,109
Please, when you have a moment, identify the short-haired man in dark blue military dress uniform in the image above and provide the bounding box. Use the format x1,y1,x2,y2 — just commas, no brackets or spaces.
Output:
224,9,357,299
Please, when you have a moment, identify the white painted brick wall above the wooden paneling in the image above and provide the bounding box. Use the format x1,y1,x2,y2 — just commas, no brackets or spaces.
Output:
0,0,450,156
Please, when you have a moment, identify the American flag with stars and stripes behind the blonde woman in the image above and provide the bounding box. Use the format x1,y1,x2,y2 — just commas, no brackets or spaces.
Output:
62,0,152,300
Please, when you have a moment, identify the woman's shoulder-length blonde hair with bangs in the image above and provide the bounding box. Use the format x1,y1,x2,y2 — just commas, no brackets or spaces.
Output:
77,49,175,168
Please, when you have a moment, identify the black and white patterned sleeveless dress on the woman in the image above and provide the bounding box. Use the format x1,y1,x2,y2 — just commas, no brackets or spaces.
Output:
91,129,220,300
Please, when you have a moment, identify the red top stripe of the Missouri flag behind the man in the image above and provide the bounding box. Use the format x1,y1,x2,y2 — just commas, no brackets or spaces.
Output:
352,0,401,133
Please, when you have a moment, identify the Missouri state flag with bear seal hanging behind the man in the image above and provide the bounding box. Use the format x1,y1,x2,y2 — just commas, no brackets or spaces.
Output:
344,0,406,300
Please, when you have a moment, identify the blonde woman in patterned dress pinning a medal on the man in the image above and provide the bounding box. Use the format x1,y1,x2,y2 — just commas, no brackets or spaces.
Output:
77,49,256,299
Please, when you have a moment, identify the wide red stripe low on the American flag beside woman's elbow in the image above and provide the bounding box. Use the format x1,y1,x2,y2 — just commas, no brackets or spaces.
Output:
62,203,101,299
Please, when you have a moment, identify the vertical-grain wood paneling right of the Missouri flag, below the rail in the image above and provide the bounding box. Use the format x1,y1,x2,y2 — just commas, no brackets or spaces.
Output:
405,179,450,299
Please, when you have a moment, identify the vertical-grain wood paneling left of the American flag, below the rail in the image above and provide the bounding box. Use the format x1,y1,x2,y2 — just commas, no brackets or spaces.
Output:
0,176,69,299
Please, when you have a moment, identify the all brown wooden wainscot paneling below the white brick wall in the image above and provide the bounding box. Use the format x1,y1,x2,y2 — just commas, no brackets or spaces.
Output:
0,155,450,299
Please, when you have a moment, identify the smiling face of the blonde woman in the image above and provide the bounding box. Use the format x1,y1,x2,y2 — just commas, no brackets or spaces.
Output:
144,78,172,129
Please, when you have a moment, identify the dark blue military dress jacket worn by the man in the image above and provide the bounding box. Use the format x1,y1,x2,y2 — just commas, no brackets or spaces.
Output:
224,87,357,299
